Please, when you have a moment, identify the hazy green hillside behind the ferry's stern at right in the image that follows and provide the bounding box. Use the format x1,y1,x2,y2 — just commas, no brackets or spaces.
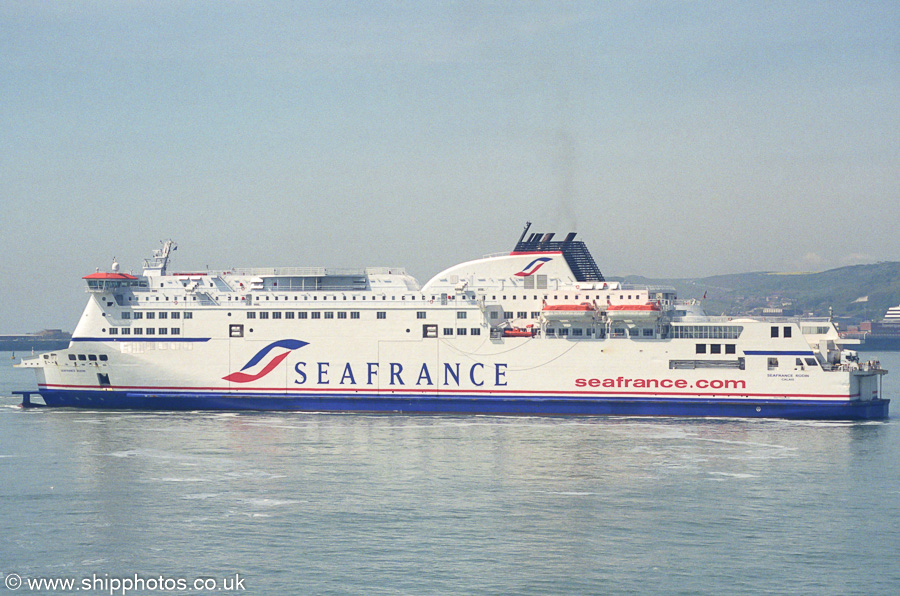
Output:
625,262,900,322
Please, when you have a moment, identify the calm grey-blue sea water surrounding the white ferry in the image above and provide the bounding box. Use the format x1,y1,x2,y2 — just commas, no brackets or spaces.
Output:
0,352,900,595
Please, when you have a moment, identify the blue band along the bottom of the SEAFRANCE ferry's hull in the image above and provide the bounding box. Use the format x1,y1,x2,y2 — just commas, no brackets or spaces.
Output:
24,389,890,420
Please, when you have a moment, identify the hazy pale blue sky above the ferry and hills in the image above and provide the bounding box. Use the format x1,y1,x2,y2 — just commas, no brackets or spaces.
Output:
0,0,900,333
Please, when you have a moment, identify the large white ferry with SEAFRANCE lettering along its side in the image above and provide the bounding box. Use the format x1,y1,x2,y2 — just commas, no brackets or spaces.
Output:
17,223,889,420
